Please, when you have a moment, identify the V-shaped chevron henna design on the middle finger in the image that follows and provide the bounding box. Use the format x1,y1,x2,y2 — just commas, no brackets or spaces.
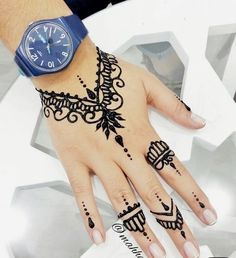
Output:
150,196,186,239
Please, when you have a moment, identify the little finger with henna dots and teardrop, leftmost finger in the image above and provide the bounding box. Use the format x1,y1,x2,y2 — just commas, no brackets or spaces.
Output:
67,164,105,245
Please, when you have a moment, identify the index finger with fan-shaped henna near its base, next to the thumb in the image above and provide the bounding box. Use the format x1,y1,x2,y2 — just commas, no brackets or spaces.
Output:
146,136,217,225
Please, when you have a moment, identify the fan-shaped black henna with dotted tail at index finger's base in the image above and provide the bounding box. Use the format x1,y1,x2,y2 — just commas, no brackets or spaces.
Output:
147,141,181,176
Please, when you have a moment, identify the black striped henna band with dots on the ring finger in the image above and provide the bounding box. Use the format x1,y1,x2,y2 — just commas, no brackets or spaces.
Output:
118,196,151,242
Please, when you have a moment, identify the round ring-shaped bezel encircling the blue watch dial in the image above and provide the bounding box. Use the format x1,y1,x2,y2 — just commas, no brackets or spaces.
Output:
23,20,74,73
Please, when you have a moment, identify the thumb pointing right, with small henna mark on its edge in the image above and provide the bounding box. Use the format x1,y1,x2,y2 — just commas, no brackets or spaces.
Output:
144,73,205,129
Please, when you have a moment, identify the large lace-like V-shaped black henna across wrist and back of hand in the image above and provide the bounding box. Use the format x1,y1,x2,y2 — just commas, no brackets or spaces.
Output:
36,47,132,160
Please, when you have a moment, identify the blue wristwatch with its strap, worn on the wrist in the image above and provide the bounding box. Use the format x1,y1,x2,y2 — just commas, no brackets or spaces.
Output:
15,14,88,77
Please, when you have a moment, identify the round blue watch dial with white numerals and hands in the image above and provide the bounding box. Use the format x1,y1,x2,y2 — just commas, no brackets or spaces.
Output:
25,22,73,72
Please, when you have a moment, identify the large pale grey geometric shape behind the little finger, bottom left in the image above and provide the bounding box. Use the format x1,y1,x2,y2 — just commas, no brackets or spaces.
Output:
9,181,117,258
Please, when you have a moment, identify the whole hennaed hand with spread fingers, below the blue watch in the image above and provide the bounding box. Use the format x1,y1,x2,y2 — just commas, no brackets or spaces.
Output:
35,39,216,257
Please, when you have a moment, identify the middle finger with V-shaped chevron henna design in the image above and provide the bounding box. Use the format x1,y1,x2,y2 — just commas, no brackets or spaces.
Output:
119,154,199,257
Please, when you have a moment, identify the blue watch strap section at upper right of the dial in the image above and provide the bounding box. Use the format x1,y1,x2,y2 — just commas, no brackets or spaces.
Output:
62,14,88,42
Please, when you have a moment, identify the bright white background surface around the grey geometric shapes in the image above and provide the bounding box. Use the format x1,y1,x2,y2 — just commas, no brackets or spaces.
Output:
0,0,236,258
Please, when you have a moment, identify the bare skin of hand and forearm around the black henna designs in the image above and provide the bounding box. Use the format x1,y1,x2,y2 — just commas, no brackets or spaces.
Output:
0,0,216,258
